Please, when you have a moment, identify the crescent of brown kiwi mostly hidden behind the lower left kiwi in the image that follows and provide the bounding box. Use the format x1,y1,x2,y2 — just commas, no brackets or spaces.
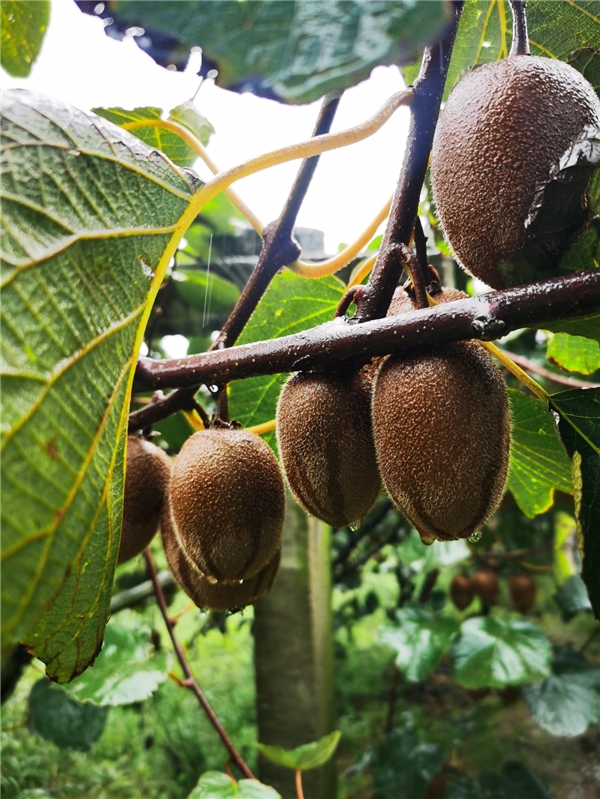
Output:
161,503,281,610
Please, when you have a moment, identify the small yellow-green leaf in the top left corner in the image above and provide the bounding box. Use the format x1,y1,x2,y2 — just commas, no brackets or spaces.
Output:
0,0,50,78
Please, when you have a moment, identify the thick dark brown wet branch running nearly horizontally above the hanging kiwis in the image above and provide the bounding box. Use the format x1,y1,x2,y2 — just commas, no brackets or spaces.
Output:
136,269,600,396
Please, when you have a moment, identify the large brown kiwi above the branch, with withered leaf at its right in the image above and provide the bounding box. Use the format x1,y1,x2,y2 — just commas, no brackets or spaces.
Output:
431,55,600,289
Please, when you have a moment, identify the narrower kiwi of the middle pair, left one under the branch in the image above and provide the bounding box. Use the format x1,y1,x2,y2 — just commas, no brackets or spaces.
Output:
277,365,381,527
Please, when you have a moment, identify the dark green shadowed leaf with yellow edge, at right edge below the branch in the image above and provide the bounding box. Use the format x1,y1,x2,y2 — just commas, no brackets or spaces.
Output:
550,389,600,618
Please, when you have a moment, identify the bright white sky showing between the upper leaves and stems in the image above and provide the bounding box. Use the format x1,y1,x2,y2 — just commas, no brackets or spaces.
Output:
0,0,408,252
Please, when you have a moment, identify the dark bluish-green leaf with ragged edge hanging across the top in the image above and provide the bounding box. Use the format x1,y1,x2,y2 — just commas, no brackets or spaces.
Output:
79,0,450,103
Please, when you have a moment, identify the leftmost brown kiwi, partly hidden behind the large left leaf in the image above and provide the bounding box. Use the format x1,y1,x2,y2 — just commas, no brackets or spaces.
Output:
117,436,171,563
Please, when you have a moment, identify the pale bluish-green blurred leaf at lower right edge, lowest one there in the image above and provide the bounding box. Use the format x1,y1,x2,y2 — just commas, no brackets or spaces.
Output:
523,646,600,738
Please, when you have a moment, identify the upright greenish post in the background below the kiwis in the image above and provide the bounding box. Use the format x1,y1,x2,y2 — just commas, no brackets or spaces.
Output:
254,494,336,799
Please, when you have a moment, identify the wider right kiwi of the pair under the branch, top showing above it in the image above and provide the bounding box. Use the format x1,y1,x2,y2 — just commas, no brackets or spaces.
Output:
373,289,510,544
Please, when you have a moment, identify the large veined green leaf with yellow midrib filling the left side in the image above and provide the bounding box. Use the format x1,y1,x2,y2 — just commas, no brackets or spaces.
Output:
0,90,195,681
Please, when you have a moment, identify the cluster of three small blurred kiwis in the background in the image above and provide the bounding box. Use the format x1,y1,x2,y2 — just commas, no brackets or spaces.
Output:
449,569,537,613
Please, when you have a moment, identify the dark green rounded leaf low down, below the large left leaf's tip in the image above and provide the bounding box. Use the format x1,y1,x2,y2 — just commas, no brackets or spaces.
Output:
28,677,108,752
